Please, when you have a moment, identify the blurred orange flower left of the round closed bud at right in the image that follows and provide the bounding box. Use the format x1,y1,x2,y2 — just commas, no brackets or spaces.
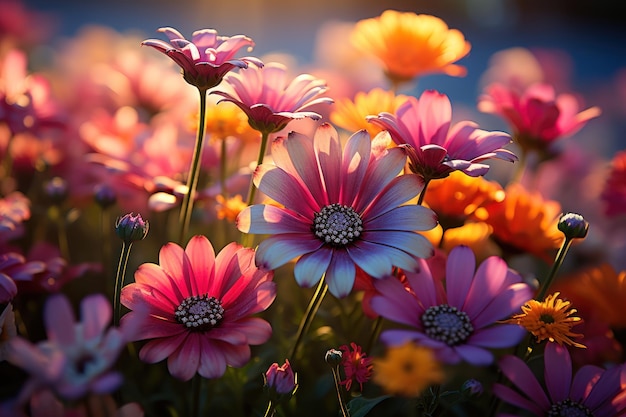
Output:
472,183,564,262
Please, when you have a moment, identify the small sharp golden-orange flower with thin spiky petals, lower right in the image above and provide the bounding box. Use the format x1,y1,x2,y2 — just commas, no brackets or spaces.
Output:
506,292,585,348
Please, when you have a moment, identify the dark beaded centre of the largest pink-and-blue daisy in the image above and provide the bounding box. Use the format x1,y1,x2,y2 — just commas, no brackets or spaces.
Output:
313,203,363,248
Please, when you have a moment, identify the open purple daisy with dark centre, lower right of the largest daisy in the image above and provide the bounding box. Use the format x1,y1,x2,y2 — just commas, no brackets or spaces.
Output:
371,246,533,365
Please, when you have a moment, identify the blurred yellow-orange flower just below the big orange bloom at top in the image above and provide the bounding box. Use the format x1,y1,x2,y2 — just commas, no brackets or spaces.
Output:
330,88,407,138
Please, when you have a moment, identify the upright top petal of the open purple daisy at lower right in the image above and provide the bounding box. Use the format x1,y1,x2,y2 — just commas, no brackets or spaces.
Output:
446,246,476,309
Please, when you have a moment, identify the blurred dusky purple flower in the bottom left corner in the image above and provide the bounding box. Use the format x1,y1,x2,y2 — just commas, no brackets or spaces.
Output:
7,294,126,400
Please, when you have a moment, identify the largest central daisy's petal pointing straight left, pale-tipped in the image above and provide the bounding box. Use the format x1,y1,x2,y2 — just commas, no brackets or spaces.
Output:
235,204,312,235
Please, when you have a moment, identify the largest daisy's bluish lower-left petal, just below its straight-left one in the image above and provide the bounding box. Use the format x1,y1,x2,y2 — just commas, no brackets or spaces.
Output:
255,232,322,270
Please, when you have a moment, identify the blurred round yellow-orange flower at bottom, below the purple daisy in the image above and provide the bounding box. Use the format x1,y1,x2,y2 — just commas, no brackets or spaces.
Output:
373,342,444,397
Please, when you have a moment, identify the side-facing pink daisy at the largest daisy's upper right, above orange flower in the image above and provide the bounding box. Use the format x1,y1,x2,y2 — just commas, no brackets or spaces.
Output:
367,90,517,181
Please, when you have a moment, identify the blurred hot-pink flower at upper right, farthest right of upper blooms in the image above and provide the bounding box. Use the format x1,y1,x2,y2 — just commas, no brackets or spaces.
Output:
478,83,600,151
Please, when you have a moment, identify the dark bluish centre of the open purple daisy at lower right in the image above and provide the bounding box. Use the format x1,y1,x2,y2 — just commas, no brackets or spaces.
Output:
422,304,474,346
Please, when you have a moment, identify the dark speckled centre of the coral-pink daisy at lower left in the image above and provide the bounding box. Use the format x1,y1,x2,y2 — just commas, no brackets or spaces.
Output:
174,294,224,331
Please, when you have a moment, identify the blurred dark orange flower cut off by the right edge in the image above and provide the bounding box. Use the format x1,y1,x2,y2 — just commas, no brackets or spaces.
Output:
559,264,626,328
